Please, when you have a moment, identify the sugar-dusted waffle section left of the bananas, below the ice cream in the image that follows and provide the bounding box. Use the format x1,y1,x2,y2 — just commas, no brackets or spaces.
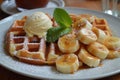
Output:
6,19,59,64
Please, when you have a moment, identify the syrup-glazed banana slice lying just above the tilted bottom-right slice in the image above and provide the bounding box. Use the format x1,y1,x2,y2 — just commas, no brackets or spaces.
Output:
87,42,109,59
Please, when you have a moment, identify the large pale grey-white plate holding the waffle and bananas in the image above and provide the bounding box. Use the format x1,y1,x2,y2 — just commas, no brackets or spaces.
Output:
0,8,120,80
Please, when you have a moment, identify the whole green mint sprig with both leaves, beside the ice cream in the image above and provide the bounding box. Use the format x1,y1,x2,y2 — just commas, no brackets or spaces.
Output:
46,8,72,42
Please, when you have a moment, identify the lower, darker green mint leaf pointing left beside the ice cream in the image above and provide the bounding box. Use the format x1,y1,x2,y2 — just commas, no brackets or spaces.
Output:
46,27,71,42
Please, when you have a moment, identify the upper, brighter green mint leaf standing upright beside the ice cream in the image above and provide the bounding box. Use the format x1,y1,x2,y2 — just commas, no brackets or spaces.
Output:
53,8,72,27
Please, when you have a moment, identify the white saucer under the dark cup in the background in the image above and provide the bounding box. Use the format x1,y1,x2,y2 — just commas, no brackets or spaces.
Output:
1,0,65,15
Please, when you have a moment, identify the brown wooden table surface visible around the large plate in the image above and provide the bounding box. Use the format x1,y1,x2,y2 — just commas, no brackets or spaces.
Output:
0,0,120,80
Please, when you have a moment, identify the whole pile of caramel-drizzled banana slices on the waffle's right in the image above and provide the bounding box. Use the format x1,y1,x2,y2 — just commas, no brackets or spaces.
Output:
56,14,120,73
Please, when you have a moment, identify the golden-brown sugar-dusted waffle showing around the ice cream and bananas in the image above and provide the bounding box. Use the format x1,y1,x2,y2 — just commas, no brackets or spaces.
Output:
6,14,116,71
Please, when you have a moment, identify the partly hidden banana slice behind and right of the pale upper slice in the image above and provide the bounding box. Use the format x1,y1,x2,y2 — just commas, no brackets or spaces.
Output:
92,27,108,43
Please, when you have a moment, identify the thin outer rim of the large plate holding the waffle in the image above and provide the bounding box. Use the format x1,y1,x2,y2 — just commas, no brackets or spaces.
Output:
0,7,120,79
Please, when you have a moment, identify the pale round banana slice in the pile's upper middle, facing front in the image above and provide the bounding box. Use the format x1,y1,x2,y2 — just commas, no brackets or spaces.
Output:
77,28,97,45
